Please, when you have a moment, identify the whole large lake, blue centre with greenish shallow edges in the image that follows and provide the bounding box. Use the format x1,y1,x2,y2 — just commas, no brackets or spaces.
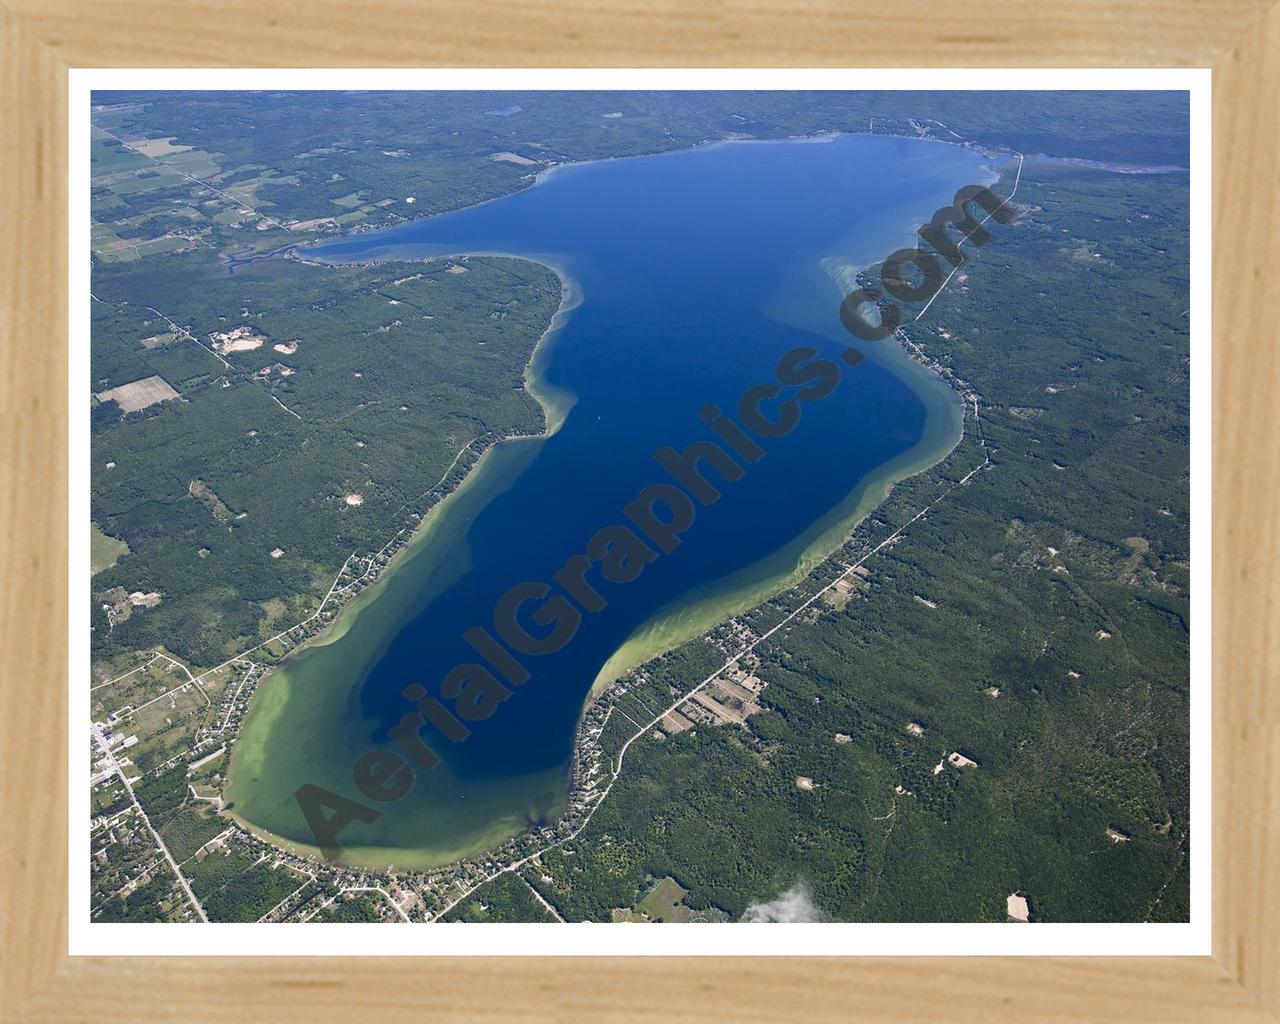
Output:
225,129,992,865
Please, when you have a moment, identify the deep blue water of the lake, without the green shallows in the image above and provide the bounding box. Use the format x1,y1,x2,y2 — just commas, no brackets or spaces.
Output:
241,137,989,847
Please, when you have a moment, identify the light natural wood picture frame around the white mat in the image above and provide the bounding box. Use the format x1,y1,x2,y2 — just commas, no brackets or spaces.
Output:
0,0,1280,1024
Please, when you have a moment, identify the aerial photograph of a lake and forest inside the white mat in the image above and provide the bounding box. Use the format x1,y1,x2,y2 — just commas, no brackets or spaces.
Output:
87,90,1187,936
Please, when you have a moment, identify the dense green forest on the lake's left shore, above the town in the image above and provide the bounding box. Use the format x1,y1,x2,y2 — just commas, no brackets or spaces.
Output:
91,253,561,667
